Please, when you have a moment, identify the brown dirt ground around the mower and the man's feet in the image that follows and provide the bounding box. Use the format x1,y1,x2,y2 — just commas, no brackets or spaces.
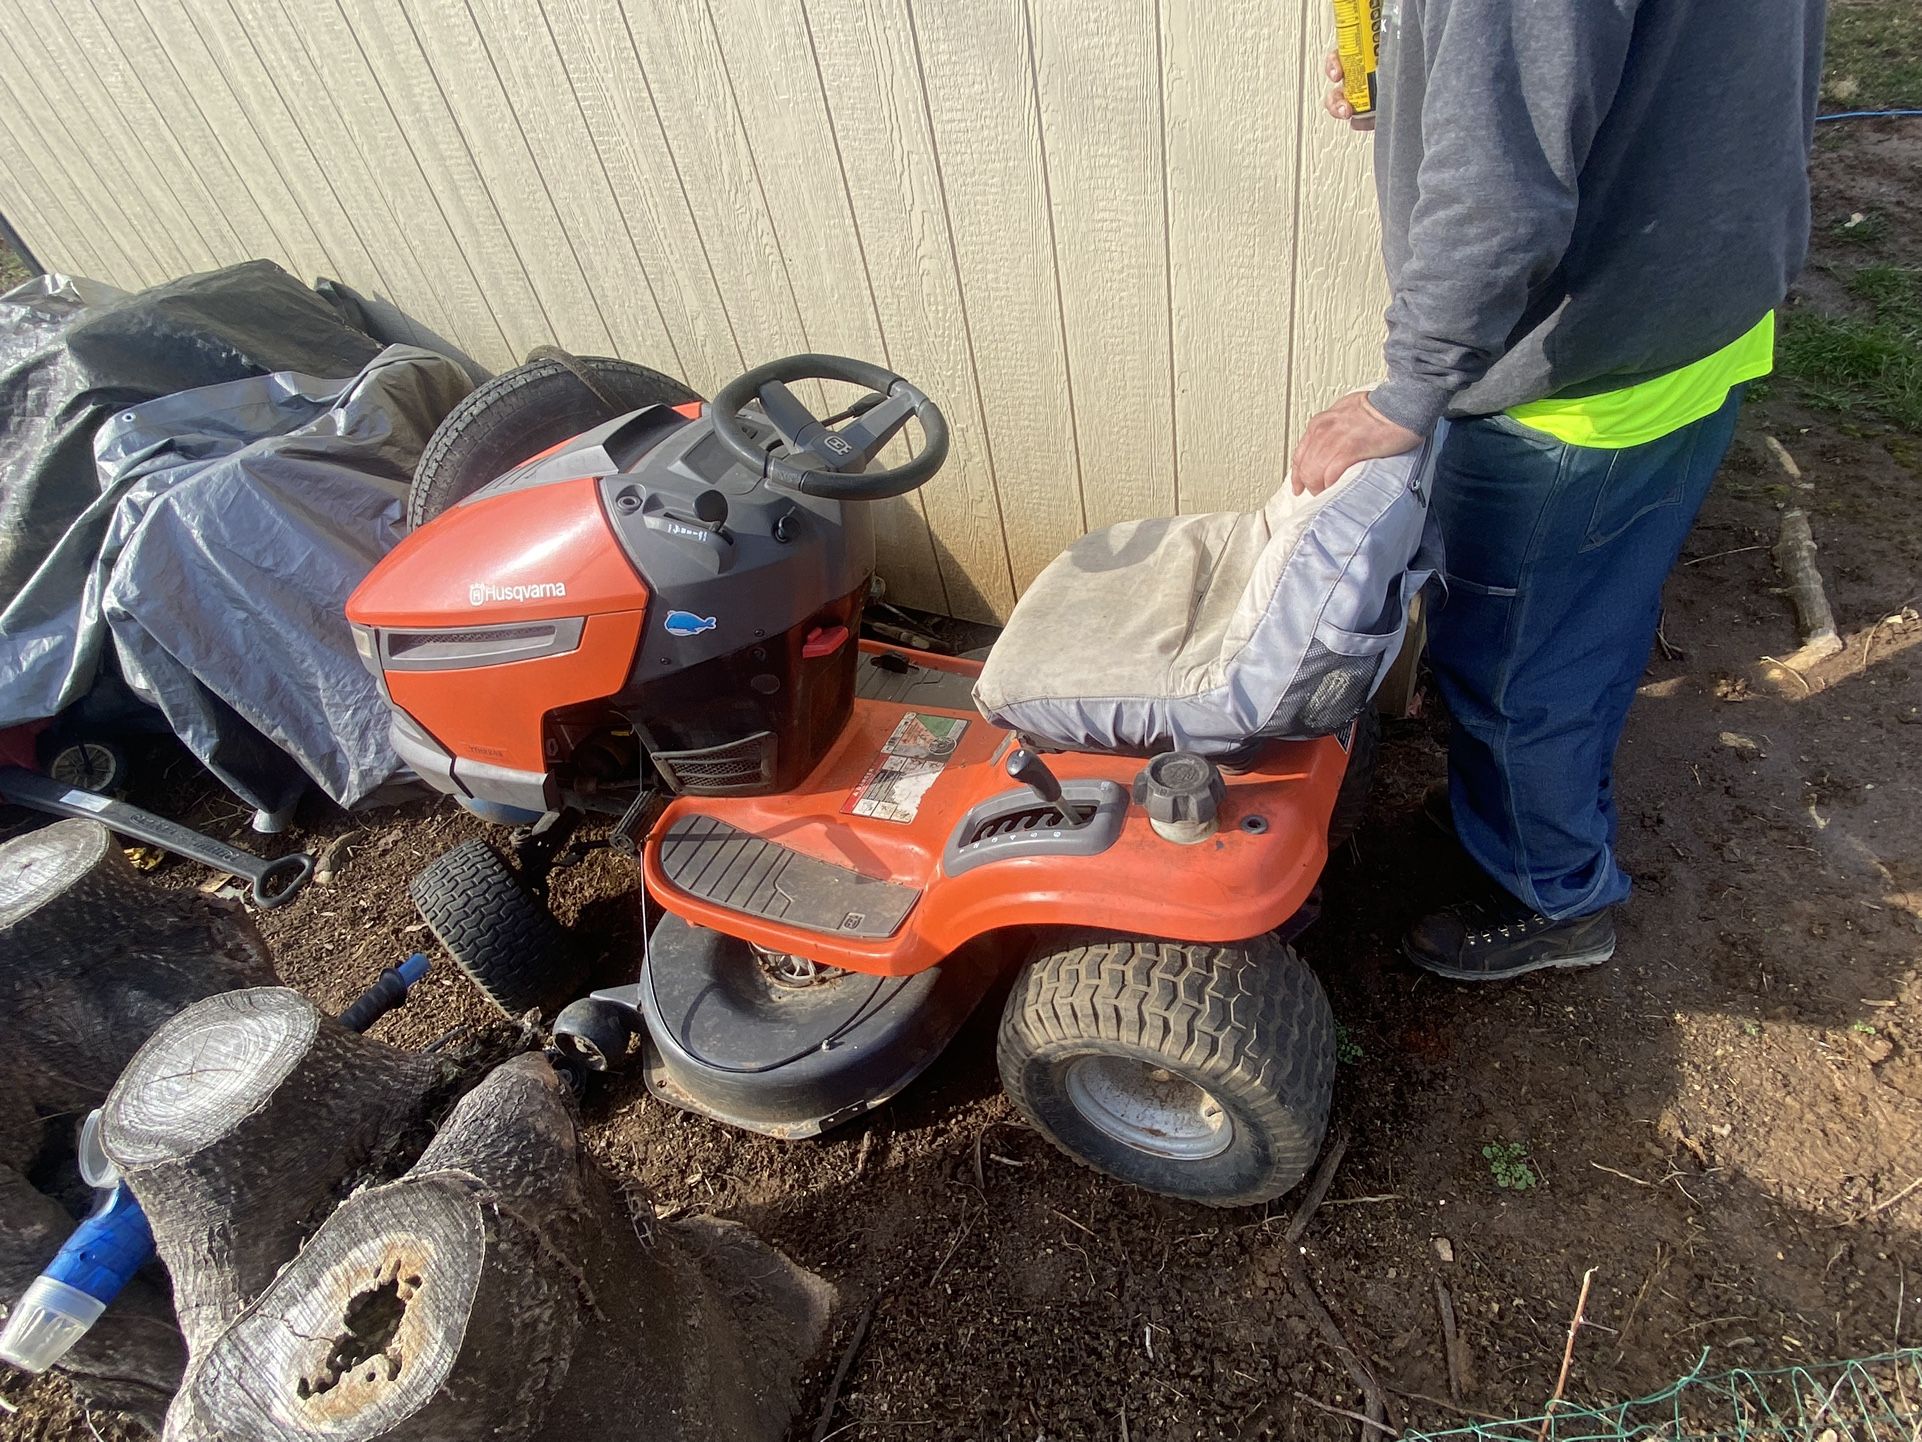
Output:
0,121,1922,1442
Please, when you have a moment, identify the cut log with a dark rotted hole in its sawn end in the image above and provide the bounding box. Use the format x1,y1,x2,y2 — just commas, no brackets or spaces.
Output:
165,1056,832,1442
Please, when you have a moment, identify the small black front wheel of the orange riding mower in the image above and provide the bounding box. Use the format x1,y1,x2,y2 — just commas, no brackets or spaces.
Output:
407,840,582,1017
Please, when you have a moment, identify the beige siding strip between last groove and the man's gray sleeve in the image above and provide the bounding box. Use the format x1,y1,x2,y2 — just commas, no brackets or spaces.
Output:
1288,15,1388,428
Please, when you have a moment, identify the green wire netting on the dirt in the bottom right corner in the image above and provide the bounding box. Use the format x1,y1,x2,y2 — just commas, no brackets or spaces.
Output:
1401,1348,1922,1442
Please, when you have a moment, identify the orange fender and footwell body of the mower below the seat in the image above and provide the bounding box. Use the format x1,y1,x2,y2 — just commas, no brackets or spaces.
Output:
644,642,1342,977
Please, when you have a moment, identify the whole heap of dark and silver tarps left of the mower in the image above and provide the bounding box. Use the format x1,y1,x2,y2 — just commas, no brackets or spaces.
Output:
0,261,471,809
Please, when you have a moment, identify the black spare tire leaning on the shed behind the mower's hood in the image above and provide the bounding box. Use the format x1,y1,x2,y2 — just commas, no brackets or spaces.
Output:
407,356,700,527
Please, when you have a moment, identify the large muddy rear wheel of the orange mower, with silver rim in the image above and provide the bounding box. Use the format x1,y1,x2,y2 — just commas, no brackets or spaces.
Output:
999,936,1334,1207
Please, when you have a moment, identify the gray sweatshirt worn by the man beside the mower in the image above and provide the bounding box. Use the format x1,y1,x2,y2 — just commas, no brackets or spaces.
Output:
1372,0,1826,433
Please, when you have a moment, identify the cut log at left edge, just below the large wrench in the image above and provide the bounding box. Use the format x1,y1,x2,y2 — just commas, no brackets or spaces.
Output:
0,821,273,1169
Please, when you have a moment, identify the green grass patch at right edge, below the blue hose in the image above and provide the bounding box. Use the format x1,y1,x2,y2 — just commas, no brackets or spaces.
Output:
1776,263,1922,431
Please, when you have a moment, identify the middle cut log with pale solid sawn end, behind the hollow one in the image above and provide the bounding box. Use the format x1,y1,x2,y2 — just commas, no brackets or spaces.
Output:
100,986,442,1354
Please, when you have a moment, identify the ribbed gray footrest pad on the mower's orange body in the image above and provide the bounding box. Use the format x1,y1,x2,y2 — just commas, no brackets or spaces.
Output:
661,815,921,940
